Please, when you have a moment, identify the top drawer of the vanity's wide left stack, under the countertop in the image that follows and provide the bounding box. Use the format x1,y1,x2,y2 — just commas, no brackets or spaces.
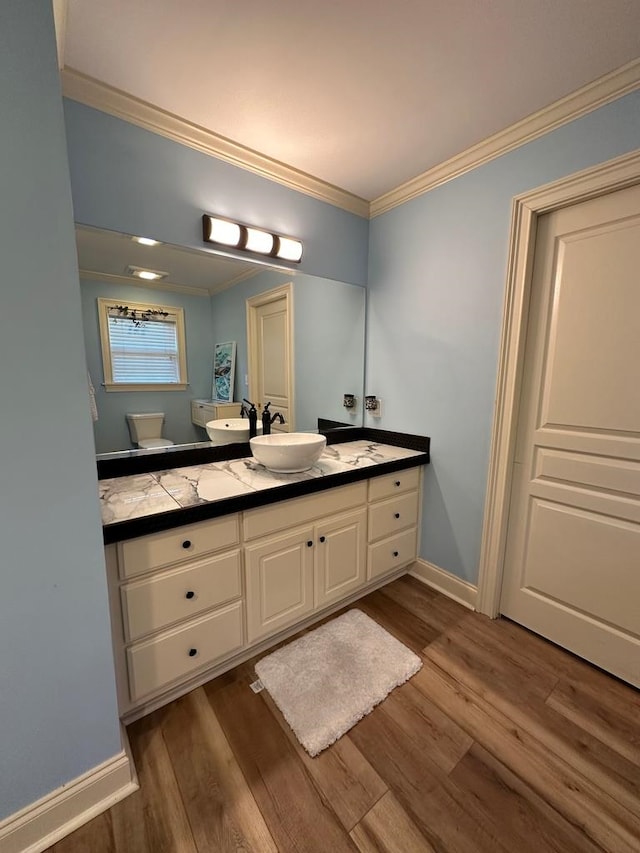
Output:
118,514,240,578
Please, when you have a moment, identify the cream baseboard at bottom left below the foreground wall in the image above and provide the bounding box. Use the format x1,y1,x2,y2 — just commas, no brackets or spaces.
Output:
0,728,138,853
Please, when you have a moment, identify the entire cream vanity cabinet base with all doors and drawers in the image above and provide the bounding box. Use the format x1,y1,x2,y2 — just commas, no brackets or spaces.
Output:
106,460,421,722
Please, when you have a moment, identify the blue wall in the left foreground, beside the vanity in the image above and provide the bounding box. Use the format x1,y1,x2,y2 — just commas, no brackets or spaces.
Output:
0,0,121,820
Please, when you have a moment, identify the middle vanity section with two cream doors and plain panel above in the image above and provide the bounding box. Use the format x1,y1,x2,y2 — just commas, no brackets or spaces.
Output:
243,482,367,643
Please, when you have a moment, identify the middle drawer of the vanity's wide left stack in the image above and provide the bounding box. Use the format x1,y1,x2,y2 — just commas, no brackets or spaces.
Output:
120,550,242,641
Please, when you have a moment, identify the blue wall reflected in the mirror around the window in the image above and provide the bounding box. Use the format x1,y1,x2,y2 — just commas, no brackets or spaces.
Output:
81,280,213,453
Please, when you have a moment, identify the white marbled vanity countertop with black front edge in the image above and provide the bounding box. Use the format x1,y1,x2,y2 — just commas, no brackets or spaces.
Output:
99,439,428,544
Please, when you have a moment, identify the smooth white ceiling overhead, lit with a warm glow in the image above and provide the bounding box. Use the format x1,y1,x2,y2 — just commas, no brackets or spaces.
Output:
64,0,640,201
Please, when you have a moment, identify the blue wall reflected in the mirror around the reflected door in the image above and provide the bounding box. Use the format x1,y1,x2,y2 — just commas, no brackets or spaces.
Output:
212,270,366,430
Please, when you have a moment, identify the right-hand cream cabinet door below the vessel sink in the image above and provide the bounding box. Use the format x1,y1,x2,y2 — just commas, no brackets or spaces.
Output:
315,508,367,607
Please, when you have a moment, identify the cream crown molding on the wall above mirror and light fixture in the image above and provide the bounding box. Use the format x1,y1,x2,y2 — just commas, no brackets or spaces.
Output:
60,67,369,218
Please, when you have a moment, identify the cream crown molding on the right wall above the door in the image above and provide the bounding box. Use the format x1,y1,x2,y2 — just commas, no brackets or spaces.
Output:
370,59,640,218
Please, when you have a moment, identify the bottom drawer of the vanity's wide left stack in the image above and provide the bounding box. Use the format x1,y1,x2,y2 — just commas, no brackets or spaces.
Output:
127,601,243,702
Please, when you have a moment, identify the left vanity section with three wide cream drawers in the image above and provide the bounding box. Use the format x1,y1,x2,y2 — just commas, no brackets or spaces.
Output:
107,513,245,711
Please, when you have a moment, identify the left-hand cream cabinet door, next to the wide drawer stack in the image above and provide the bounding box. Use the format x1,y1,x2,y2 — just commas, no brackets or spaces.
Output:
245,526,317,643
